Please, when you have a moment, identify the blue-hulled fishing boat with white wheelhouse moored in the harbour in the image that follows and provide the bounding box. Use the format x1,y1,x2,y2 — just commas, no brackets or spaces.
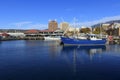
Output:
61,34,106,46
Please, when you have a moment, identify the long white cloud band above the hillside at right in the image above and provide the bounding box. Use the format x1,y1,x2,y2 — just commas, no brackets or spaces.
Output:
70,15,120,27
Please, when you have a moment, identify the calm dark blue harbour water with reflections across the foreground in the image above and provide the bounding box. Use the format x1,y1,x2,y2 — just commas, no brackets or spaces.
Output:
0,40,120,80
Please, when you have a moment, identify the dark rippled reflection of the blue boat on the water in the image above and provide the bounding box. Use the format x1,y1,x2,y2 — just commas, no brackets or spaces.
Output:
61,45,106,75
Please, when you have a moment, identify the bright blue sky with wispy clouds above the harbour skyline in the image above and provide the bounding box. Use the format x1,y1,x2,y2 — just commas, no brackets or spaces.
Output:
0,0,120,29
